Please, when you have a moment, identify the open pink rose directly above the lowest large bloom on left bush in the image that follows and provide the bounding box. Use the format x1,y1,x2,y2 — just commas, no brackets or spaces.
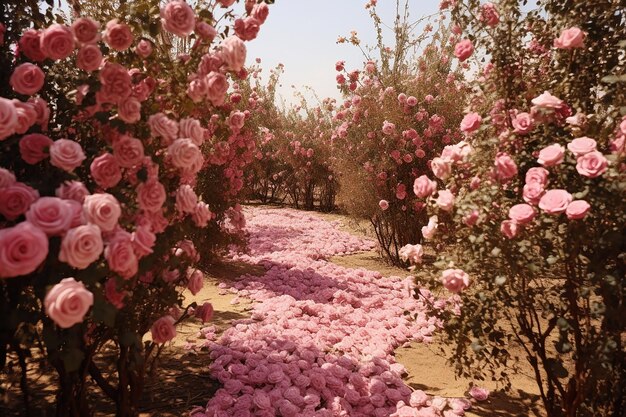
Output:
59,224,104,269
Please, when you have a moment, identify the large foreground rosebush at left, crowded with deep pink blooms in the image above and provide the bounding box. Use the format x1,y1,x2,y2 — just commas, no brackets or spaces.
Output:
0,0,268,416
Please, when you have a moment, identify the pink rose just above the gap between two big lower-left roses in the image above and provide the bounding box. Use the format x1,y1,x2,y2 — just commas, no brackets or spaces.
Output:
26,197,73,236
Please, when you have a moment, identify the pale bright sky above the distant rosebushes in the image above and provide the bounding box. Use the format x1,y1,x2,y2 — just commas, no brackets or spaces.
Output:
247,0,439,107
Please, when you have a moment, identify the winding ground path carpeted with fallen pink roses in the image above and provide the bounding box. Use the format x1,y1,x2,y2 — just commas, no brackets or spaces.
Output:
192,208,468,417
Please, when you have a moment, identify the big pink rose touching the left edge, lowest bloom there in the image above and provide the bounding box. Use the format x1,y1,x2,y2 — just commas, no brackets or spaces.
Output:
0,222,48,278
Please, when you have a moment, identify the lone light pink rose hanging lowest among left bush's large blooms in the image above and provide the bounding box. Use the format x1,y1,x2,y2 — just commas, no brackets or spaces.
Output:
44,278,93,329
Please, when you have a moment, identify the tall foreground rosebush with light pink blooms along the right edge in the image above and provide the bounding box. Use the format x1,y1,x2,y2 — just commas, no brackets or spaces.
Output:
398,0,626,417
